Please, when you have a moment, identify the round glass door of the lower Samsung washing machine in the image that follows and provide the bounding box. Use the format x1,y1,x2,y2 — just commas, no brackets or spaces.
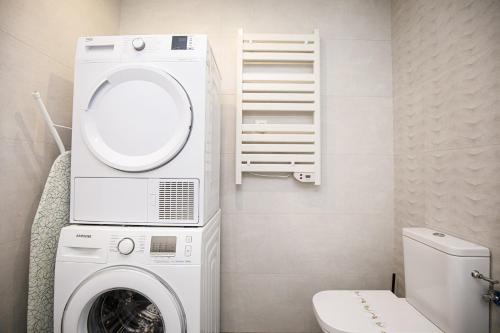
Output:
61,266,187,333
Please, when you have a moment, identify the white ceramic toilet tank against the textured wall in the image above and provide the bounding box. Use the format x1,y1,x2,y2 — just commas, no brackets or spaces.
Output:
403,228,490,333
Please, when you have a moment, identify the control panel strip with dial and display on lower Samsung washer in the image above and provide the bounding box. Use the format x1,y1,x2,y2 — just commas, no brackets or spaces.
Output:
57,226,202,265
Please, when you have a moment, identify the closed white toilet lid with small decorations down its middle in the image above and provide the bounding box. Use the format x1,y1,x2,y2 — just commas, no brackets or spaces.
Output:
313,290,443,333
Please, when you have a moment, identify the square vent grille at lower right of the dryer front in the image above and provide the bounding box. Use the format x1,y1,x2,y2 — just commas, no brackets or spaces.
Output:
158,180,195,220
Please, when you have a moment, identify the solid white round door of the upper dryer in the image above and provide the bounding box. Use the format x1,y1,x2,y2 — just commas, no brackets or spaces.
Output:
81,66,193,172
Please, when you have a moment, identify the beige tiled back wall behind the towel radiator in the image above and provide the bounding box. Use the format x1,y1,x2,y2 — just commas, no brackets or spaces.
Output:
120,0,393,332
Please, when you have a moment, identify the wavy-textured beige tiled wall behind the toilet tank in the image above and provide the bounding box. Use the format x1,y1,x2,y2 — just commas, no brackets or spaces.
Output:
392,0,500,326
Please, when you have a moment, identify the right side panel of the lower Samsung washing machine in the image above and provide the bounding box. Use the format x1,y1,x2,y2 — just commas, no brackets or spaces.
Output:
200,211,220,333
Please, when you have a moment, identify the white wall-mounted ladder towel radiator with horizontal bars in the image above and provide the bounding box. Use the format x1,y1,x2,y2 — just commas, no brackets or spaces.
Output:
236,29,321,185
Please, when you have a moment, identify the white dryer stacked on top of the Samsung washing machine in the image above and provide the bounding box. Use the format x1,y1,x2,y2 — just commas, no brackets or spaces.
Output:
70,35,220,226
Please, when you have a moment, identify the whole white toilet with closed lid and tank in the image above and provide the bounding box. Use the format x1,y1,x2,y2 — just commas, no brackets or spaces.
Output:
313,228,490,333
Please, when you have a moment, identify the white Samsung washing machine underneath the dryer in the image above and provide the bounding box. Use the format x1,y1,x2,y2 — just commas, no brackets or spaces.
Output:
54,213,220,333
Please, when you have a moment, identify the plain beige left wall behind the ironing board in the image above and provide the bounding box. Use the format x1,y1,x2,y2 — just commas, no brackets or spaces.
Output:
0,0,120,332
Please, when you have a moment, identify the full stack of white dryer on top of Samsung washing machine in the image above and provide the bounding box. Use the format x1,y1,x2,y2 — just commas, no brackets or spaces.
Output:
54,35,220,333
